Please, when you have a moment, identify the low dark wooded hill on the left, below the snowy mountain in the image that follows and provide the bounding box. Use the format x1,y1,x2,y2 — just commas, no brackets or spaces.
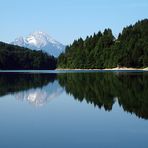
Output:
0,42,56,70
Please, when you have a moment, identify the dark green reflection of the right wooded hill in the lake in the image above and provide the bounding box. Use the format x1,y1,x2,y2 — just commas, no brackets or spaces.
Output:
58,73,148,119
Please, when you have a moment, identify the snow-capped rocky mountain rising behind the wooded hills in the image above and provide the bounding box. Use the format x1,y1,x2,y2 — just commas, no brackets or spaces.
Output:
11,31,65,57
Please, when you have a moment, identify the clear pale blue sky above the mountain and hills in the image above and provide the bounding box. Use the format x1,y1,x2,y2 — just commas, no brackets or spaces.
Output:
0,0,148,44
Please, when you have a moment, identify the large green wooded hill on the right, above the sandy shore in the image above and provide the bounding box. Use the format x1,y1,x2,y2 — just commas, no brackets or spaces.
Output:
58,19,148,69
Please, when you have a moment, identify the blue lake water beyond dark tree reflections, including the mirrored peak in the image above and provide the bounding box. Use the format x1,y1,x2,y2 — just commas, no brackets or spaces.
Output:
0,72,148,148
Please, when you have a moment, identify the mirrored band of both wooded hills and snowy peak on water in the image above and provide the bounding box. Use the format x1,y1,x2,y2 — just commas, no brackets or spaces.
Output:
0,73,148,119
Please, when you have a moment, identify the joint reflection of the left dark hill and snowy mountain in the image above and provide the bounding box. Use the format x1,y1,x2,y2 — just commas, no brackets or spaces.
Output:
0,73,63,106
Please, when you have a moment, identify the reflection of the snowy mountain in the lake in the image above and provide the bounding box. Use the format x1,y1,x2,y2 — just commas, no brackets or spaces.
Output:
14,81,63,106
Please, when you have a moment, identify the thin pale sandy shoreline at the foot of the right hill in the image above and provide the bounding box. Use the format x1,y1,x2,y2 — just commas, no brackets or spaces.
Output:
56,67,148,71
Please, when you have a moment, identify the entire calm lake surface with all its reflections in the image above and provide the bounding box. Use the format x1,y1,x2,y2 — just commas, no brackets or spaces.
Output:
0,71,148,148
